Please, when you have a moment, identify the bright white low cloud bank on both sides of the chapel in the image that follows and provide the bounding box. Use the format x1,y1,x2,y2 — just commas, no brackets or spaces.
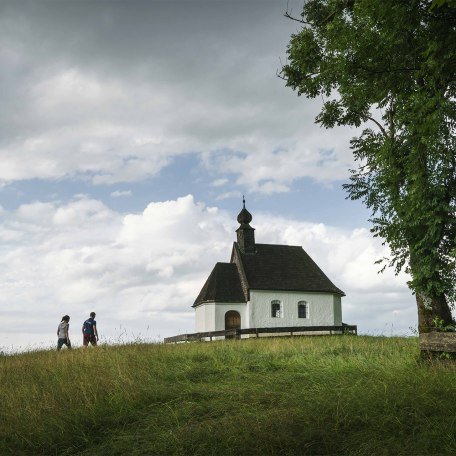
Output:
0,195,415,347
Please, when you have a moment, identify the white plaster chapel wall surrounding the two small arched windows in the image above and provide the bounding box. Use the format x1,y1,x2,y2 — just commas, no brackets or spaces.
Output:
249,290,342,328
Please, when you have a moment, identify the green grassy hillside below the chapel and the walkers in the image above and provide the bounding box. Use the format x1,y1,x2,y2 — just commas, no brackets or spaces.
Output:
0,336,456,455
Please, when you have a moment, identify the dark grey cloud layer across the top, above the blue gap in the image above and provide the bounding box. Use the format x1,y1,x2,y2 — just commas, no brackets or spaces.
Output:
0,1,352,194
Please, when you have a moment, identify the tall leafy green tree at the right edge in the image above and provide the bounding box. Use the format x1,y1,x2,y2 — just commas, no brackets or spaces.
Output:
281,0,456,332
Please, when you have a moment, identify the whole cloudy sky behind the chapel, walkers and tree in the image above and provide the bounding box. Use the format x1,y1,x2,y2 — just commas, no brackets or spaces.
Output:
0,0,422,352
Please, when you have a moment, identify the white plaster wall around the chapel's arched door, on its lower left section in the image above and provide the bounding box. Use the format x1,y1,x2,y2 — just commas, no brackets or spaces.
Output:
195,302,250,332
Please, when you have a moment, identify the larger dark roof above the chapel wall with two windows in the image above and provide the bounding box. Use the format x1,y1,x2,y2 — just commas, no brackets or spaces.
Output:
231,242,345,296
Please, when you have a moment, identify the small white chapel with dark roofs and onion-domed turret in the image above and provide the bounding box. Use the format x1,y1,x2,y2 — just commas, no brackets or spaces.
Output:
192,201,345,336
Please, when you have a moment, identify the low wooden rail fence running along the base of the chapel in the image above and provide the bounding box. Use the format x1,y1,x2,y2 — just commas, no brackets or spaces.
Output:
164,325,358,344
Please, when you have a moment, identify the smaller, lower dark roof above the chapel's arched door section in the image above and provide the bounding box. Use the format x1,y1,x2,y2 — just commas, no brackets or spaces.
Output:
193,263,246,307
